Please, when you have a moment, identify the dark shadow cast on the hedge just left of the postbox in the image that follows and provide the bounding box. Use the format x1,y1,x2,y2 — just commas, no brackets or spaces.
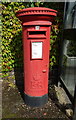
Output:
10,31,24,99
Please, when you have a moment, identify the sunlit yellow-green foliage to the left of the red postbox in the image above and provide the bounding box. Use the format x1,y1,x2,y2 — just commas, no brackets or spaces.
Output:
1,2,25,71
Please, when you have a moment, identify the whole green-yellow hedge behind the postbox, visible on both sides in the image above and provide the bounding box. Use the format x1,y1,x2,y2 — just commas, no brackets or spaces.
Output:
1,2,63,72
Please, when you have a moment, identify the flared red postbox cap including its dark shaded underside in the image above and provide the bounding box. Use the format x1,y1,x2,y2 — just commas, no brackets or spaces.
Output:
16,7,57,25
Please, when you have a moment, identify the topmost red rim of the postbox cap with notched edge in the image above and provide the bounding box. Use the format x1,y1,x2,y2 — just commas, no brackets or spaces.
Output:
16,7,57,17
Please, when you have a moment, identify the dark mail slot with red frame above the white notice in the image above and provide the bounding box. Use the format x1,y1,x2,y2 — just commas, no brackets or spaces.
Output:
28,31,46,38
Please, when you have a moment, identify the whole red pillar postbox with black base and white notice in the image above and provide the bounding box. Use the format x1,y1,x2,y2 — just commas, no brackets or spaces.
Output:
16,7,57,106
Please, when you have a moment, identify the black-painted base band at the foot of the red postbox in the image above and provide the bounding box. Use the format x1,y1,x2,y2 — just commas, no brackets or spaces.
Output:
24,93,48,107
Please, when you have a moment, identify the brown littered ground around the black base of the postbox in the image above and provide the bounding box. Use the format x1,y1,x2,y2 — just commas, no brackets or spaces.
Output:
2,70,70,120
